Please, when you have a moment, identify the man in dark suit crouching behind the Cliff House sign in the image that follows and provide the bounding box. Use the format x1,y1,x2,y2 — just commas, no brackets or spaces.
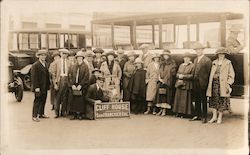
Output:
85,77,109,120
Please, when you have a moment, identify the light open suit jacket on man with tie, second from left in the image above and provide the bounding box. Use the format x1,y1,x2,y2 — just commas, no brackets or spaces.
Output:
51,59,71,84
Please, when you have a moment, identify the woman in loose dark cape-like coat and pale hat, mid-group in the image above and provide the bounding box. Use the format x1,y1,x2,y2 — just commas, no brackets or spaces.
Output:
127,58,146,114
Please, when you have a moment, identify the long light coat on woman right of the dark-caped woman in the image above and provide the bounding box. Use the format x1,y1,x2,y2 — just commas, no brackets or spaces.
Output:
146,62,160,101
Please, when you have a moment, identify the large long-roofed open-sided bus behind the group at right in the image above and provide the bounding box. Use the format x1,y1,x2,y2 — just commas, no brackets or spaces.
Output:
91,12,248,97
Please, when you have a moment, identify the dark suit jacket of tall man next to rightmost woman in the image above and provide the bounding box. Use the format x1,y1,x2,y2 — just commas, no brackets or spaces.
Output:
193,55,212,90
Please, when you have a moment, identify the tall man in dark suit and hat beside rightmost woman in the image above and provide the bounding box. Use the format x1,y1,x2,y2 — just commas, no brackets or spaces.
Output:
191,43,212,123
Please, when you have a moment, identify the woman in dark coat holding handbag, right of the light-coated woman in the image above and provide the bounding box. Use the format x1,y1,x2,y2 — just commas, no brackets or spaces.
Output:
156,50,176,116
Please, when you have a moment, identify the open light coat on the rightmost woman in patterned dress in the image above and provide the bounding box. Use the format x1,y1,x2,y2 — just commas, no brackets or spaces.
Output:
207,58,235,97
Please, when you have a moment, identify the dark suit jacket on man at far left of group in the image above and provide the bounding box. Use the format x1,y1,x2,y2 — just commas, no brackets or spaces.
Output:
31,60,50,92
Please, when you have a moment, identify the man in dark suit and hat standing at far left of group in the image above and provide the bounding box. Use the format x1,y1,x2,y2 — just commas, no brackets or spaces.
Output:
31,50,50,122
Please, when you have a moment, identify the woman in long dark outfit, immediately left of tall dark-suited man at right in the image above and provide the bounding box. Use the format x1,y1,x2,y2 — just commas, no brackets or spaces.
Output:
173,52,194,117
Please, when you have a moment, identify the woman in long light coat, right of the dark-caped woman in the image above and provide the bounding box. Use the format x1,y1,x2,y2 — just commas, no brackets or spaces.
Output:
144,53,160,114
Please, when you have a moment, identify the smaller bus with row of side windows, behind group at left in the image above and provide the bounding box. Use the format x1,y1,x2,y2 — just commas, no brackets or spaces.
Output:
9,29,91,89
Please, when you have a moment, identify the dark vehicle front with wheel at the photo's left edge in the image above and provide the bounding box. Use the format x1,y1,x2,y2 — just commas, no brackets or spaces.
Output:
8,62,23,102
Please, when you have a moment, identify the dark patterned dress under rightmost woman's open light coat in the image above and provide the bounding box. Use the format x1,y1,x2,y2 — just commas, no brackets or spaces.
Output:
209,65,230,112
